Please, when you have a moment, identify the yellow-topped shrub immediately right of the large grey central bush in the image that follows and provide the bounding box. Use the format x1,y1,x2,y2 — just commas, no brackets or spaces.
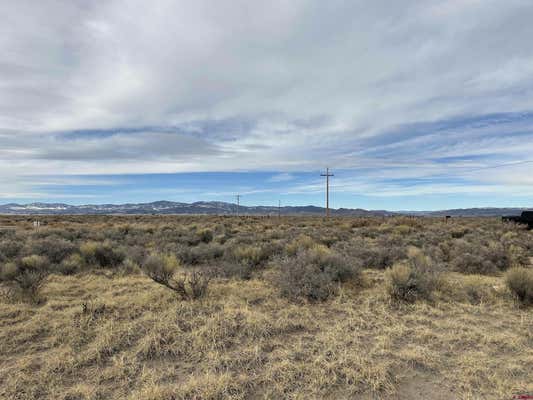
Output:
385,253,439,303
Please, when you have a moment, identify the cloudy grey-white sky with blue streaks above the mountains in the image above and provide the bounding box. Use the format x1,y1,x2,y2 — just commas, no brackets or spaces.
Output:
0,0,533,210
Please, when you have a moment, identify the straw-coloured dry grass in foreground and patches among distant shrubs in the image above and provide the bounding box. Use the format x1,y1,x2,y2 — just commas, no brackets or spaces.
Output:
0,217,533,400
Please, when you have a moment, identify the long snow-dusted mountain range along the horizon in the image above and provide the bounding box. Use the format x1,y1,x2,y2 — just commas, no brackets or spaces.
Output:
0,201,527,217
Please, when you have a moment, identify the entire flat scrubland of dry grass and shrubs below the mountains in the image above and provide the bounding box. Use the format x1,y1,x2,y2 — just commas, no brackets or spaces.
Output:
0,216,533,400
